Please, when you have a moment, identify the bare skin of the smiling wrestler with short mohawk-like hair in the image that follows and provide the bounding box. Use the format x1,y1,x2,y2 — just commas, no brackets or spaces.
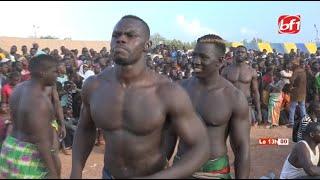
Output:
179,43,250,179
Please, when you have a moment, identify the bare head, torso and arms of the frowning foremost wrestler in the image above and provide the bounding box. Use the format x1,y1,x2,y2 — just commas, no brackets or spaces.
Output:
71,18,209,178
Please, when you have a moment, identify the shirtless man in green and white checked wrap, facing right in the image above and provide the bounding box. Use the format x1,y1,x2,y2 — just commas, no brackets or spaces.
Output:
0,55,60,179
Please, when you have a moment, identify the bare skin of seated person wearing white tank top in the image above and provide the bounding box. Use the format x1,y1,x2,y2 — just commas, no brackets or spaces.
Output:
288,126,320,176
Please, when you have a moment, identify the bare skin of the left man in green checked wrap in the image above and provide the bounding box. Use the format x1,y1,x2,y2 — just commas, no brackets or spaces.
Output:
10,63,60,178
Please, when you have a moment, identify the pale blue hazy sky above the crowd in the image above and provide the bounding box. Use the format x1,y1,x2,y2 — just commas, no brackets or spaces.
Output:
0,1,320,43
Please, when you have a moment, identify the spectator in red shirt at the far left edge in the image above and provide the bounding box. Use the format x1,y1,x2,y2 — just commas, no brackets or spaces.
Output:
1,71,21,113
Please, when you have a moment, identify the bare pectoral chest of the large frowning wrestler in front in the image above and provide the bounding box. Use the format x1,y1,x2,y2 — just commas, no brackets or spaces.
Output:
90,84,165,135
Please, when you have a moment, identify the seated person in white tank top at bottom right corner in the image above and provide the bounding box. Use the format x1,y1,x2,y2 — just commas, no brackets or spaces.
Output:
280,122,320,179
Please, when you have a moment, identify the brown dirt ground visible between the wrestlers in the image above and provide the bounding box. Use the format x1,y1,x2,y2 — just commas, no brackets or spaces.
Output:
60,127,293,179
